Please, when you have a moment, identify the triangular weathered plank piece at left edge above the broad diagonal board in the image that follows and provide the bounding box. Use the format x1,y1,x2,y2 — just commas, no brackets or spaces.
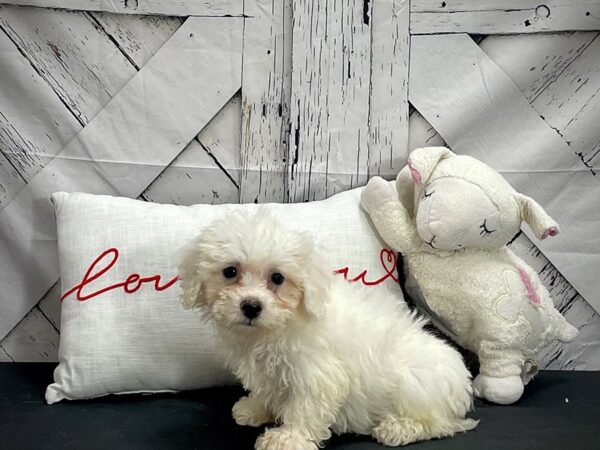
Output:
0,21,81,189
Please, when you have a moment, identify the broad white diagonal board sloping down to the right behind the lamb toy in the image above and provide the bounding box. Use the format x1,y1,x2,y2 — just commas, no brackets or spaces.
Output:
410,35,600,308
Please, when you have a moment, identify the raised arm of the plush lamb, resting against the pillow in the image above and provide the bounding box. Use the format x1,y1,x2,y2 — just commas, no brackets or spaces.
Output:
360,177,424,253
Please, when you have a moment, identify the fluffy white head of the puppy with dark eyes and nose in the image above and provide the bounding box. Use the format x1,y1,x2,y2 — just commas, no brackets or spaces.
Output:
179,208,331,333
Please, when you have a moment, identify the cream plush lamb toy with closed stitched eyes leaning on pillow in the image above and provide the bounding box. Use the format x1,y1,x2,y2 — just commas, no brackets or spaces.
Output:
361,147,578,404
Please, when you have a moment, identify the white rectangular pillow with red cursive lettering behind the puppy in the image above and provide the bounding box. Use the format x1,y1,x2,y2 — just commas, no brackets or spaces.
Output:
46,189,402,403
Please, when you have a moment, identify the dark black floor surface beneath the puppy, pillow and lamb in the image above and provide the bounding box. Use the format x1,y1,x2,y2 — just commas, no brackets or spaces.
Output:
0,363,600,450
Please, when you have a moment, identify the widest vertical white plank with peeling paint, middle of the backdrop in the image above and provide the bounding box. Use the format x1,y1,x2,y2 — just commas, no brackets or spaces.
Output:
289,0,371,202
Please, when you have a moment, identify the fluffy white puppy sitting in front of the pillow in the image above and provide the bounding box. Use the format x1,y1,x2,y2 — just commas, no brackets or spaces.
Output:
180,208,477,450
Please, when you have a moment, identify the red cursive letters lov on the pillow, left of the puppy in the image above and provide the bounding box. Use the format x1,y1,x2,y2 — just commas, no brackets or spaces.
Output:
60,248,179,302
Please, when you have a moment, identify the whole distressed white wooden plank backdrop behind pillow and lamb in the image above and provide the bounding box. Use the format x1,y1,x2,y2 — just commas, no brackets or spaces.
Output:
0,0,600,370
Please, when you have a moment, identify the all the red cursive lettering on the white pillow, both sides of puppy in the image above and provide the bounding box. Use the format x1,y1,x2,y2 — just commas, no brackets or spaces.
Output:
60,247,398,302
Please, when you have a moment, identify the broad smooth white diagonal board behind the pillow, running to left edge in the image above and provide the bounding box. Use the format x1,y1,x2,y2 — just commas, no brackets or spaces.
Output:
0,18,242,342
